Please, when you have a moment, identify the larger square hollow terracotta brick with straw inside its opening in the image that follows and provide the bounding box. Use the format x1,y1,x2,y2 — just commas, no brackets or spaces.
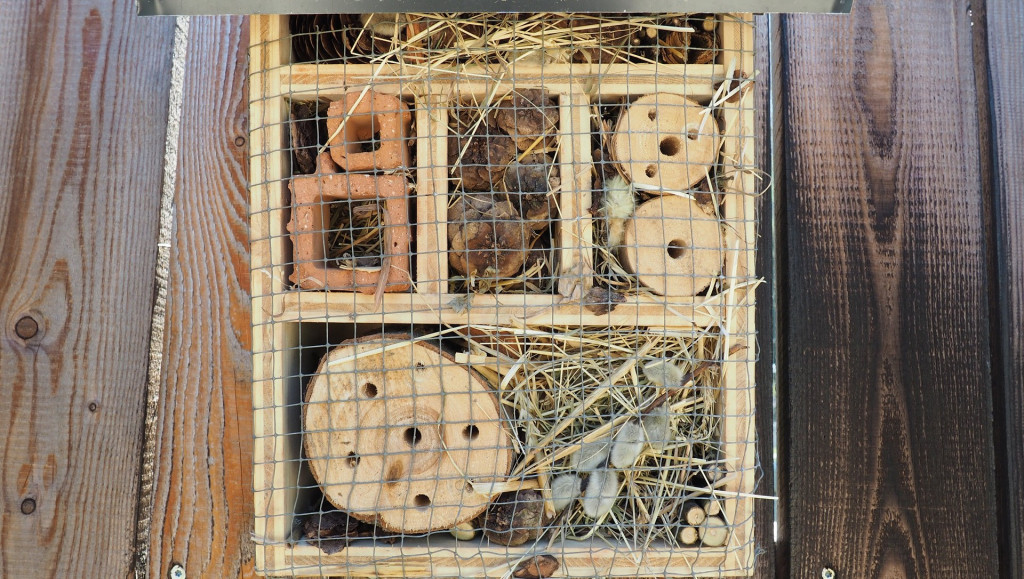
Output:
288,154,412,294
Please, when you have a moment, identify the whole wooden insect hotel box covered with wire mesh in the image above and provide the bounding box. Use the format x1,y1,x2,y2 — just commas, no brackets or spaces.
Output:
250,13,762,577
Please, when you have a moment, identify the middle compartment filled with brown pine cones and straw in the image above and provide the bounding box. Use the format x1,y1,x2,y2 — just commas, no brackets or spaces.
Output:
447,84,582,294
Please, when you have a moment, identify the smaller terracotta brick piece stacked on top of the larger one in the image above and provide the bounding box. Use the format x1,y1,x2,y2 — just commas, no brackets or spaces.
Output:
327,90,413,172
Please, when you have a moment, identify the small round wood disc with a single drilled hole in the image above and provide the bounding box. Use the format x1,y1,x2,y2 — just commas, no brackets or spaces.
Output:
620,195,723,295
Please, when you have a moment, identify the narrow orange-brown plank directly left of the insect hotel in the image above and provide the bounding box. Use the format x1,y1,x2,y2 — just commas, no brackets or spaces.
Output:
150,16,254,577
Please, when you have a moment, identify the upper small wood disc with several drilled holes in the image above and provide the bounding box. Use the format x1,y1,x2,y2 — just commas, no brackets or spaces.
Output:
611,92,719,191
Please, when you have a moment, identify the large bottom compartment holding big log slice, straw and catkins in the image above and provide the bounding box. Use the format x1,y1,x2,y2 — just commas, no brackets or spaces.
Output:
252,323,753,577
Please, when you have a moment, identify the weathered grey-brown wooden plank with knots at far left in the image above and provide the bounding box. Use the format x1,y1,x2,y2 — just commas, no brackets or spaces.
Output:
0,0,173,577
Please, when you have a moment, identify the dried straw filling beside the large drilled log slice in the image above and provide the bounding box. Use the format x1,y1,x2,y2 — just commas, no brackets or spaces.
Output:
469,326,728,545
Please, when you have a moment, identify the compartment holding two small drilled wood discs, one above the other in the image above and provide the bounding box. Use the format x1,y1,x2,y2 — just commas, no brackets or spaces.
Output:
591,44,757,324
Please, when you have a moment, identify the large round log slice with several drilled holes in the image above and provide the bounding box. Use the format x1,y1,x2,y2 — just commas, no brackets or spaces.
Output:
302,335,512,533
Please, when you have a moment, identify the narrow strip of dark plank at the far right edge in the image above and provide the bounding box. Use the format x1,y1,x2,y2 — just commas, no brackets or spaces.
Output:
986,0,1024,579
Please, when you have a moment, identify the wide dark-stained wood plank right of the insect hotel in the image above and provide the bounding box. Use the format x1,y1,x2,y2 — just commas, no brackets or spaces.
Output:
781,0,999,577
